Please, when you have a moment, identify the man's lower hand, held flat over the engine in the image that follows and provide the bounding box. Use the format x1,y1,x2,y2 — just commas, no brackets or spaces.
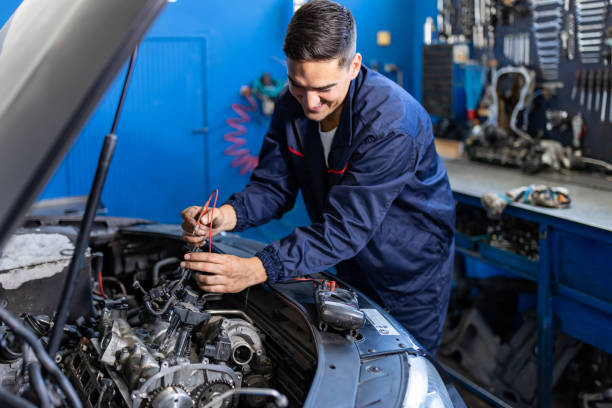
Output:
181,252,268,293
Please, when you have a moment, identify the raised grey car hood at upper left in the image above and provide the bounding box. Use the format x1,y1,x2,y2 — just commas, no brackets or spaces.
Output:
0,0,165,248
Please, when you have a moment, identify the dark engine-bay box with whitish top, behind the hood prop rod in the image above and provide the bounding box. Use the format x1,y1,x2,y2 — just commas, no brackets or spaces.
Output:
0,233,93,321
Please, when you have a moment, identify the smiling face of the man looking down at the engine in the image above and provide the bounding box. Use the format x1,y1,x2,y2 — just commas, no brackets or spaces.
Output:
287,54,361,122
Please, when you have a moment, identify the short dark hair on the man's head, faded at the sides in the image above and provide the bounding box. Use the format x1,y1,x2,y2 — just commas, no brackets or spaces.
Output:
283,0,357,66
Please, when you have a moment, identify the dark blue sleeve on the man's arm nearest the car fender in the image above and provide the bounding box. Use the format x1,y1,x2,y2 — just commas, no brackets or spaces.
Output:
256,124,424,283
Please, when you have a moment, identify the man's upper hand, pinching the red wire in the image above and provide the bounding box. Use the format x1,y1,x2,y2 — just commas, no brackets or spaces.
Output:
181,204,237,247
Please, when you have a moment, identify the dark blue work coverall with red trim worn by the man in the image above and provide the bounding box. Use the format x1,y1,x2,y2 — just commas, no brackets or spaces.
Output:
228,66,455,349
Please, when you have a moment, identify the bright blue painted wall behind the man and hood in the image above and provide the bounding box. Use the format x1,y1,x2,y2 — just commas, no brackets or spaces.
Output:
0,0,435,241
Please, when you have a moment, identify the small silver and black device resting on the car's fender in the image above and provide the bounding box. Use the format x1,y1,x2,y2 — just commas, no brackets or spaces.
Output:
314,281,365,331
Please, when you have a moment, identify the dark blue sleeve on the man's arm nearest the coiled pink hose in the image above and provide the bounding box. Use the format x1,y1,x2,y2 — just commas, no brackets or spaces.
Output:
226,105,298,232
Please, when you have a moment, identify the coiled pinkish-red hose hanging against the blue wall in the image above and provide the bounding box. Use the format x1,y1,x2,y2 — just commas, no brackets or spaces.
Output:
223,88,259,174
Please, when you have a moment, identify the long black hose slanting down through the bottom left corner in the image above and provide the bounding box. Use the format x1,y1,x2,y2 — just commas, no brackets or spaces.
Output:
0,307,82,408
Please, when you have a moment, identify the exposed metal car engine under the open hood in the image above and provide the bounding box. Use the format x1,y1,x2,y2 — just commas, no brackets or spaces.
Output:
0,225,315,408
